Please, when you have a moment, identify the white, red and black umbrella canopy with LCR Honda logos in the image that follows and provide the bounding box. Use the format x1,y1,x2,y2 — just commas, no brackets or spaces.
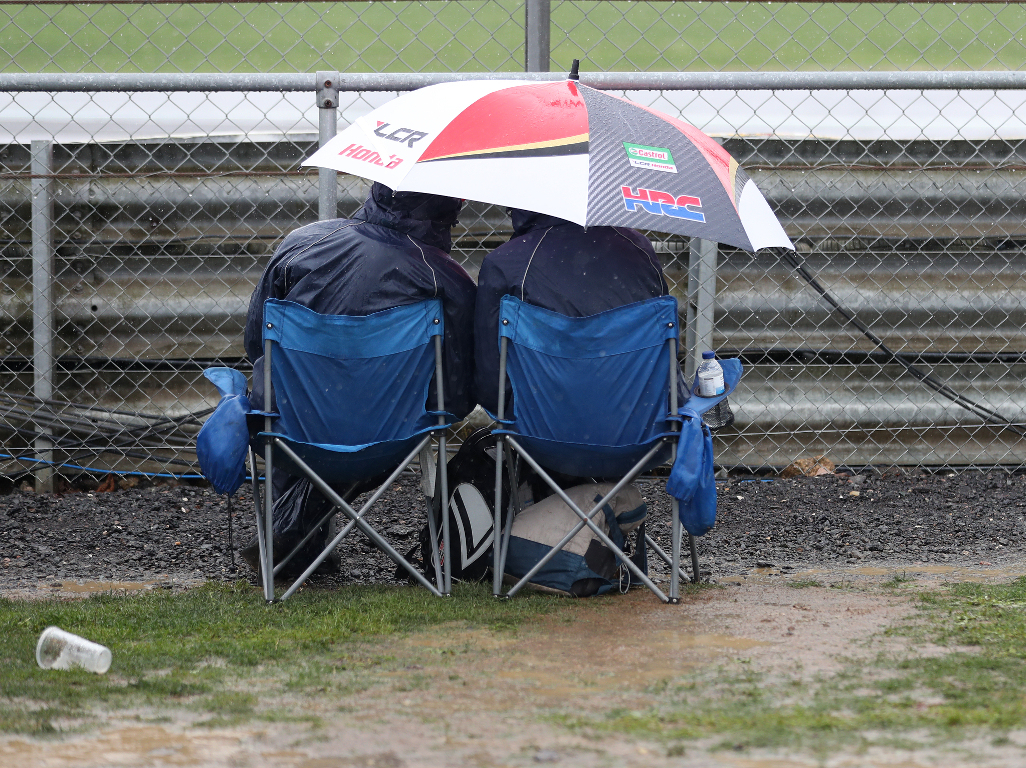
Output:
303,80,793,251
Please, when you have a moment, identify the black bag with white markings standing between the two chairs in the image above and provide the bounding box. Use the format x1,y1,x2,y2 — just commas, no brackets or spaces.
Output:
421,428,510,581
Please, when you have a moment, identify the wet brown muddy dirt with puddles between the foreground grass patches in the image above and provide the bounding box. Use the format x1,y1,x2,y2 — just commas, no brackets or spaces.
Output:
6,562,1026,768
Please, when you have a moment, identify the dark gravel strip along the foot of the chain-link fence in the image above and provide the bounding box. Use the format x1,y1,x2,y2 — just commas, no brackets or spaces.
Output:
0,463,1026,594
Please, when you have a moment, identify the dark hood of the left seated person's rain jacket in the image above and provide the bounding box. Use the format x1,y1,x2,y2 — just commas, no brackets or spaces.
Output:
353,181,463,253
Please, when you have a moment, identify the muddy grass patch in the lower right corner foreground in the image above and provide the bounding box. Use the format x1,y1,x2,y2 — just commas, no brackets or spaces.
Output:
563,577,1026,755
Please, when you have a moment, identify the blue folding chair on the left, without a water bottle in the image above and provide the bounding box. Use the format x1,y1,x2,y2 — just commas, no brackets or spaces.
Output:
248,298,455,602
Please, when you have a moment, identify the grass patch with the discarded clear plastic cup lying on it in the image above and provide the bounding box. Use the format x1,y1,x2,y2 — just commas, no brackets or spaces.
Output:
0,583,573,735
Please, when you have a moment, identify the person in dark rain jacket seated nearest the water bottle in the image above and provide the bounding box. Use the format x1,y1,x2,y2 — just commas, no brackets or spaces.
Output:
474,208,686,416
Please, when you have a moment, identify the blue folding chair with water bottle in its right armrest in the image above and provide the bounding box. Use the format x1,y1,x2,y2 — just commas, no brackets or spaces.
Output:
492,295,715,603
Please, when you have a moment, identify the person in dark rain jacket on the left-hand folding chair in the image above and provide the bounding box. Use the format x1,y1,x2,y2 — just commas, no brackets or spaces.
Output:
241,184,476,572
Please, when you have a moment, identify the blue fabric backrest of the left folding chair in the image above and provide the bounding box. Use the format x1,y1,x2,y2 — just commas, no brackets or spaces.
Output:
258,298,444,446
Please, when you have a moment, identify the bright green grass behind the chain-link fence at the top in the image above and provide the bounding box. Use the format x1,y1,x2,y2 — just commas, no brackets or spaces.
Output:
0,0,1026,72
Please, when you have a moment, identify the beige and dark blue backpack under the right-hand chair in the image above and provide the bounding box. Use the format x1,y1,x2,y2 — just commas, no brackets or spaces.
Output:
505,483,648,597
